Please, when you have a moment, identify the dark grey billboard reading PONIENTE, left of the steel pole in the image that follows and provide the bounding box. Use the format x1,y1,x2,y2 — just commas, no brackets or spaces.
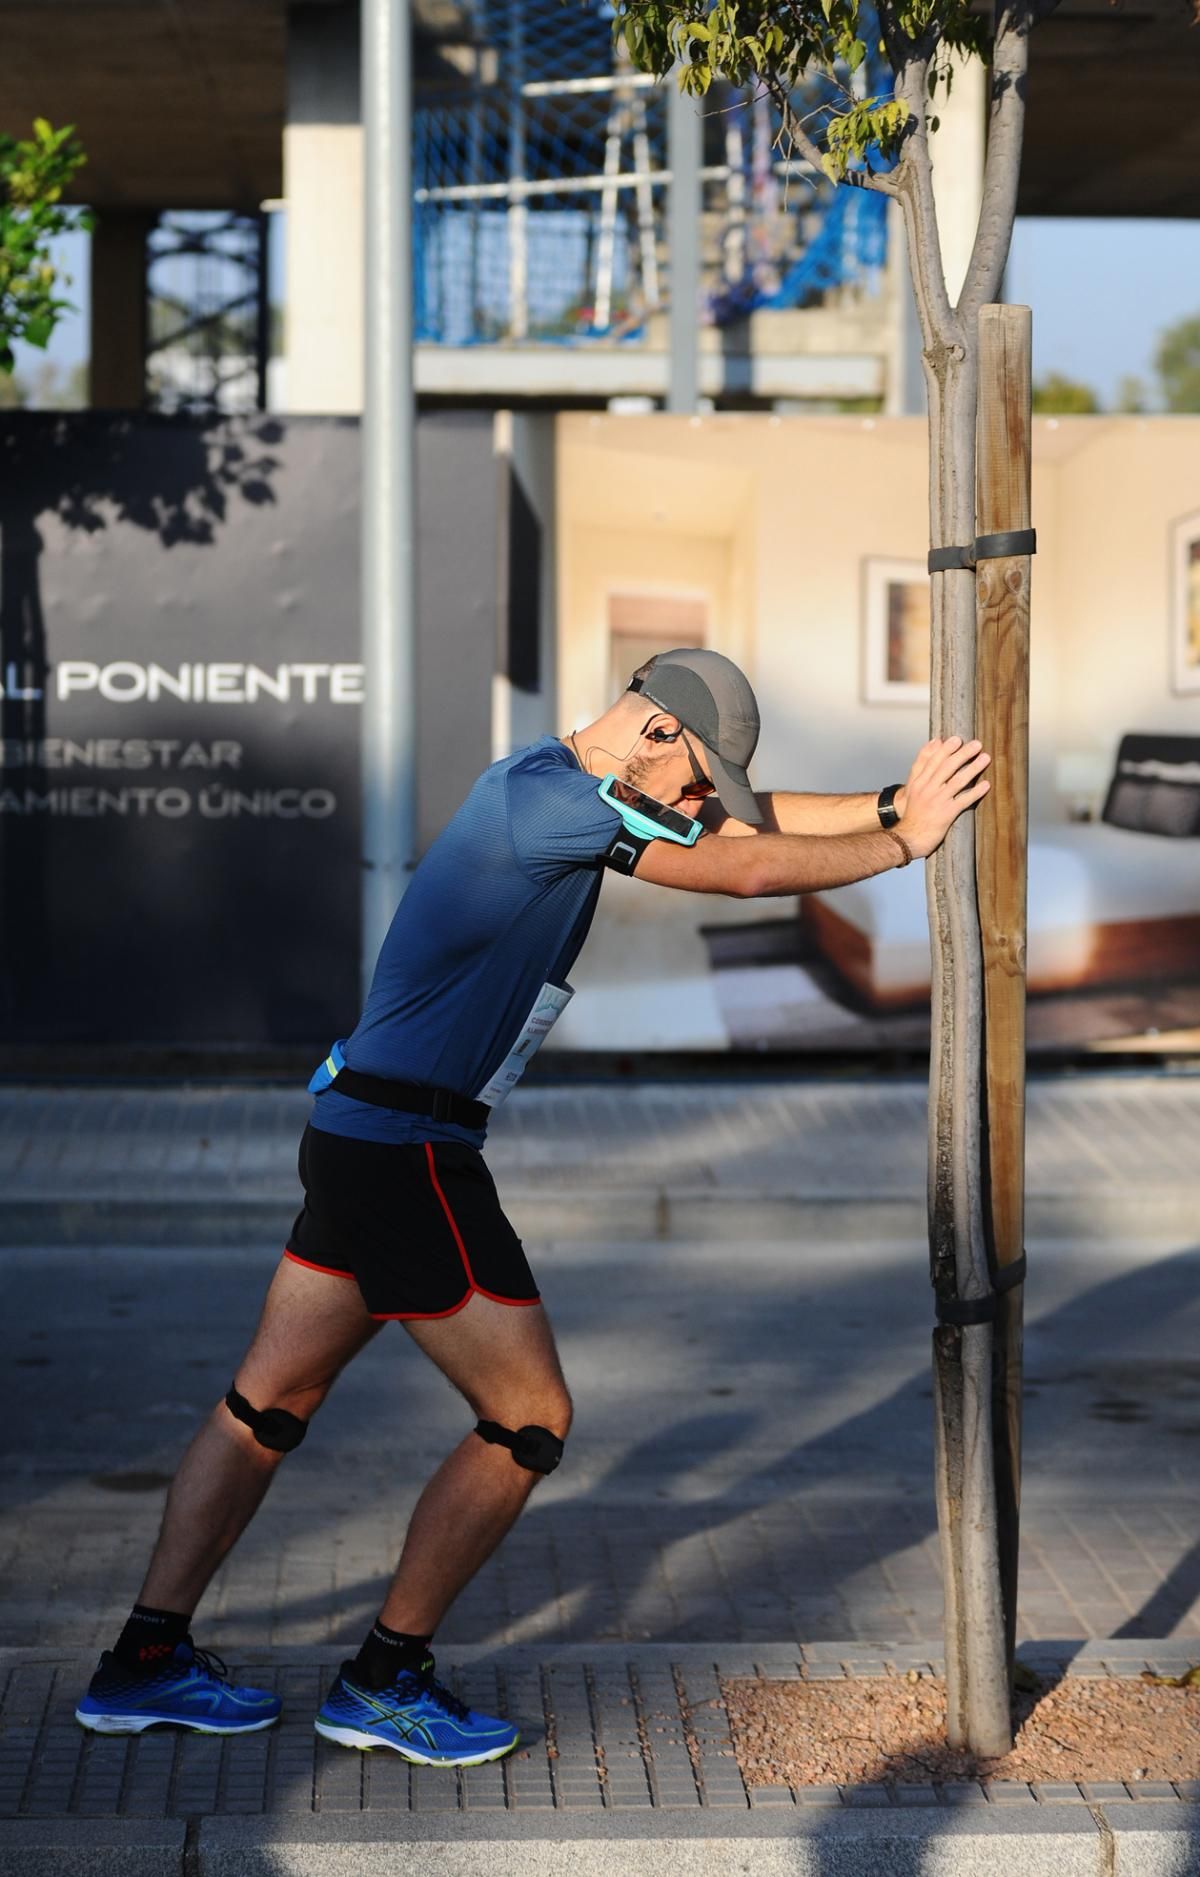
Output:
0,413,362,1047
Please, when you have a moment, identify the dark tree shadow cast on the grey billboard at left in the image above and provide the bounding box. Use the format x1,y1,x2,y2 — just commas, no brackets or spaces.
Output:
0,411,284,1032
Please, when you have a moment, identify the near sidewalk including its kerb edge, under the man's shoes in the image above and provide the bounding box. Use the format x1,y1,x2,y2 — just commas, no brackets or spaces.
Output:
0,1642,1200,1877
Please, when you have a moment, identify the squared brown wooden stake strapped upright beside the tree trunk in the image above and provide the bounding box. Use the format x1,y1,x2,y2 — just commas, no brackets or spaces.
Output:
975,306,1033,1676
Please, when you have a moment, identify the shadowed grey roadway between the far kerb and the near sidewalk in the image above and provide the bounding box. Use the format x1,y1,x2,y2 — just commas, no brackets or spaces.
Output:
0,1241,1200,1648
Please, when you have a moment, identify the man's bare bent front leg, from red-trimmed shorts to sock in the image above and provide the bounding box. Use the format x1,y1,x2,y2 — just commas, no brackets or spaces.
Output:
379,1295,571,1635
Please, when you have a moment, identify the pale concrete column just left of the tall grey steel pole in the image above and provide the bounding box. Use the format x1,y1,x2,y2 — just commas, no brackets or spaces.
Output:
284,6,364,415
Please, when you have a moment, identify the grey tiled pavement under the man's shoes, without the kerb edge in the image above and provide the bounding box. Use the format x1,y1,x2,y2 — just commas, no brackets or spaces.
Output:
0,1644,1200,1819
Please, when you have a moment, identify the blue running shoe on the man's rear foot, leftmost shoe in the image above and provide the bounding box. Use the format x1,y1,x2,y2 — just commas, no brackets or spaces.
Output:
75,1640,284,1734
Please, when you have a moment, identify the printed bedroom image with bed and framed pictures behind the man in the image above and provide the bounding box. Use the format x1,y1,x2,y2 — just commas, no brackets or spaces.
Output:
554,415,1200,1055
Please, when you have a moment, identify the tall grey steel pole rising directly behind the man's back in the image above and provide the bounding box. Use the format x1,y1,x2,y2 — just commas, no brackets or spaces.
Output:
362,0,417,995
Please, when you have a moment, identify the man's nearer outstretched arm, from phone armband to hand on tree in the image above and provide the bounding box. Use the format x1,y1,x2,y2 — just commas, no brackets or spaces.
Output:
635,736,992,899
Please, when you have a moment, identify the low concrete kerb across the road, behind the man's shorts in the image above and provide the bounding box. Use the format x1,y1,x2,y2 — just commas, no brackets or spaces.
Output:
0,1181,1196,1246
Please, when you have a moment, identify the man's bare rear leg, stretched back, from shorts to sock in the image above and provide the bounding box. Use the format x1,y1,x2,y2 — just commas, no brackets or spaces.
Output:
137,1258,375,1614
